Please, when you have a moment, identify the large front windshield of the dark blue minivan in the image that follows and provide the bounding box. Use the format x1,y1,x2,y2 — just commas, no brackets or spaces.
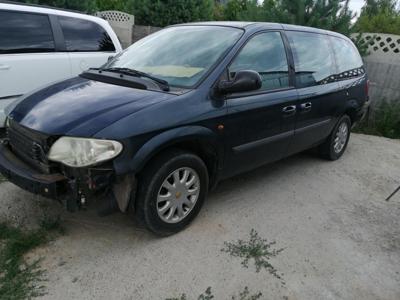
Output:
103,25,243,88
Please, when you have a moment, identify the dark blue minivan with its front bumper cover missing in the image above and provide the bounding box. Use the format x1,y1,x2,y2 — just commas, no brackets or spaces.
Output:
0,22,369,235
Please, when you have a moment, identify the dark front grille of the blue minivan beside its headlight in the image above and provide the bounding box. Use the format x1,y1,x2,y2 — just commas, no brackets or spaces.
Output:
7,121,52,174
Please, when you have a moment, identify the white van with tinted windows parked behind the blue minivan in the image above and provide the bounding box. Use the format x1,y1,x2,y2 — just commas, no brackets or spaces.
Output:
0,3,122,127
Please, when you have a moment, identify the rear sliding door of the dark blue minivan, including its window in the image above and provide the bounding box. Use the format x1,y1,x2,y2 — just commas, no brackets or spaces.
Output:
286,31,345,154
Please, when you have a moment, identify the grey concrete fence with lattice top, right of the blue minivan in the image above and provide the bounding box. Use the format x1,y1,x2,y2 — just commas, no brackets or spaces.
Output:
363,33,400,106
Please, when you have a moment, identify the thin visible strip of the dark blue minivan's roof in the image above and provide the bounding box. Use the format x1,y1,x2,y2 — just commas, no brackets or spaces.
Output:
174,21,347,39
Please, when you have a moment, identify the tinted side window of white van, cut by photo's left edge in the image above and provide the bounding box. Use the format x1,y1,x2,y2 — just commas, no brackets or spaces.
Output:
0,11,55,54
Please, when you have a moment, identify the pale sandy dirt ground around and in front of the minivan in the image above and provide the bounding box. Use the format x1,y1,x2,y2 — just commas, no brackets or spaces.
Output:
0,134,400,300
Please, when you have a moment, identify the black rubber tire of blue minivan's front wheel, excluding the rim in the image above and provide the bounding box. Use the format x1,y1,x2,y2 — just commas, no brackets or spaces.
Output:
138,153,208,236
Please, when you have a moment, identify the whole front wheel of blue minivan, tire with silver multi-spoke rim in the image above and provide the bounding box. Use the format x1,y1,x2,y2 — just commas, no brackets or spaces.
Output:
134,149,209,236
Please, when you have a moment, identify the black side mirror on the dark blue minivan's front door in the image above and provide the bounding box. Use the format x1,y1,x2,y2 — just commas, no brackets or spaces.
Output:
218,70,262,94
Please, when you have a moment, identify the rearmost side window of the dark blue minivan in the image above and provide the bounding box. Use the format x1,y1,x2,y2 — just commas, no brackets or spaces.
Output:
331,37,364,80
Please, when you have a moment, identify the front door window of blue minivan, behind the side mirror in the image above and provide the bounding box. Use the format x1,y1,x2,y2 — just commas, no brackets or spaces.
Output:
229,32,289,90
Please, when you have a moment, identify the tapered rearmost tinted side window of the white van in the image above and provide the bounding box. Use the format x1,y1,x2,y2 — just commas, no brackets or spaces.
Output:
58,17,115,52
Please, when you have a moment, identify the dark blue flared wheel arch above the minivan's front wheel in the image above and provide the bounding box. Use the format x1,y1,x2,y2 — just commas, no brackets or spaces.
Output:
117,126,224,174
